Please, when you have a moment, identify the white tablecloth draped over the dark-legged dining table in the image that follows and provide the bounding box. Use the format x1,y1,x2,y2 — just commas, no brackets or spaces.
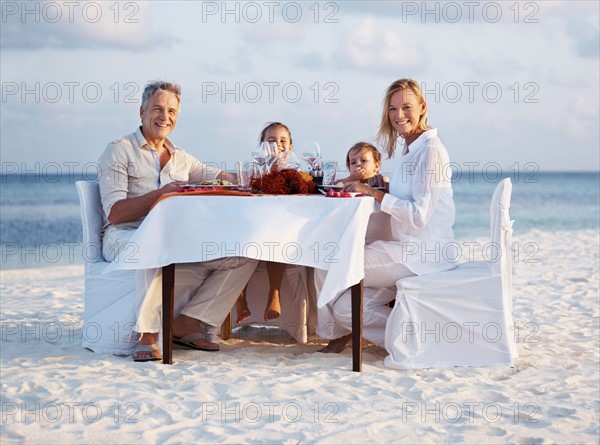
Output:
107,195,374,307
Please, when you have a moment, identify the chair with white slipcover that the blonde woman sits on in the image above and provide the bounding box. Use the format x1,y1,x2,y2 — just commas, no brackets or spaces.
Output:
385,178,518,369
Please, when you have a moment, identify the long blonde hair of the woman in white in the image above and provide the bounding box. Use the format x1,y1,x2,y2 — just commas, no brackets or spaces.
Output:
376,79,431,158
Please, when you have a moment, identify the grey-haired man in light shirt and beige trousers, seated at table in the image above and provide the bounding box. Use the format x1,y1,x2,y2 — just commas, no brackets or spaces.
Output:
99,81,257,361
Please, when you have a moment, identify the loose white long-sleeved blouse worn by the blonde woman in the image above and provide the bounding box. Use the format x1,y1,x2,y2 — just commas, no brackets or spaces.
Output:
375,129,458,275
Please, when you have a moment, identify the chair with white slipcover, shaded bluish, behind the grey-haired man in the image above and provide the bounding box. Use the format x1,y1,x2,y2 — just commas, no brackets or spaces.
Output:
75,181,137,355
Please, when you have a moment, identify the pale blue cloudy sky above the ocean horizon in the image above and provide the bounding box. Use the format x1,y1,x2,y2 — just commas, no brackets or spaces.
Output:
0,1,600,176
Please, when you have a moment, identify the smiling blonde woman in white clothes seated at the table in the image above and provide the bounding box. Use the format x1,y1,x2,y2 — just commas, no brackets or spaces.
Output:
319,79,456,352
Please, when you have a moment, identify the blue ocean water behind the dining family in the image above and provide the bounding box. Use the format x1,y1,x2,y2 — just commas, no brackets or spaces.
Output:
0,172,600,269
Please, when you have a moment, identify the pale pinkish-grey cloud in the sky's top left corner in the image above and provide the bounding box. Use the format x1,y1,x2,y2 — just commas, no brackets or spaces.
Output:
0,1,177,51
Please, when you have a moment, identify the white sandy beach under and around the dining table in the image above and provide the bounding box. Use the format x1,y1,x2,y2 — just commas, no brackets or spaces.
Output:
0,227,600,444
